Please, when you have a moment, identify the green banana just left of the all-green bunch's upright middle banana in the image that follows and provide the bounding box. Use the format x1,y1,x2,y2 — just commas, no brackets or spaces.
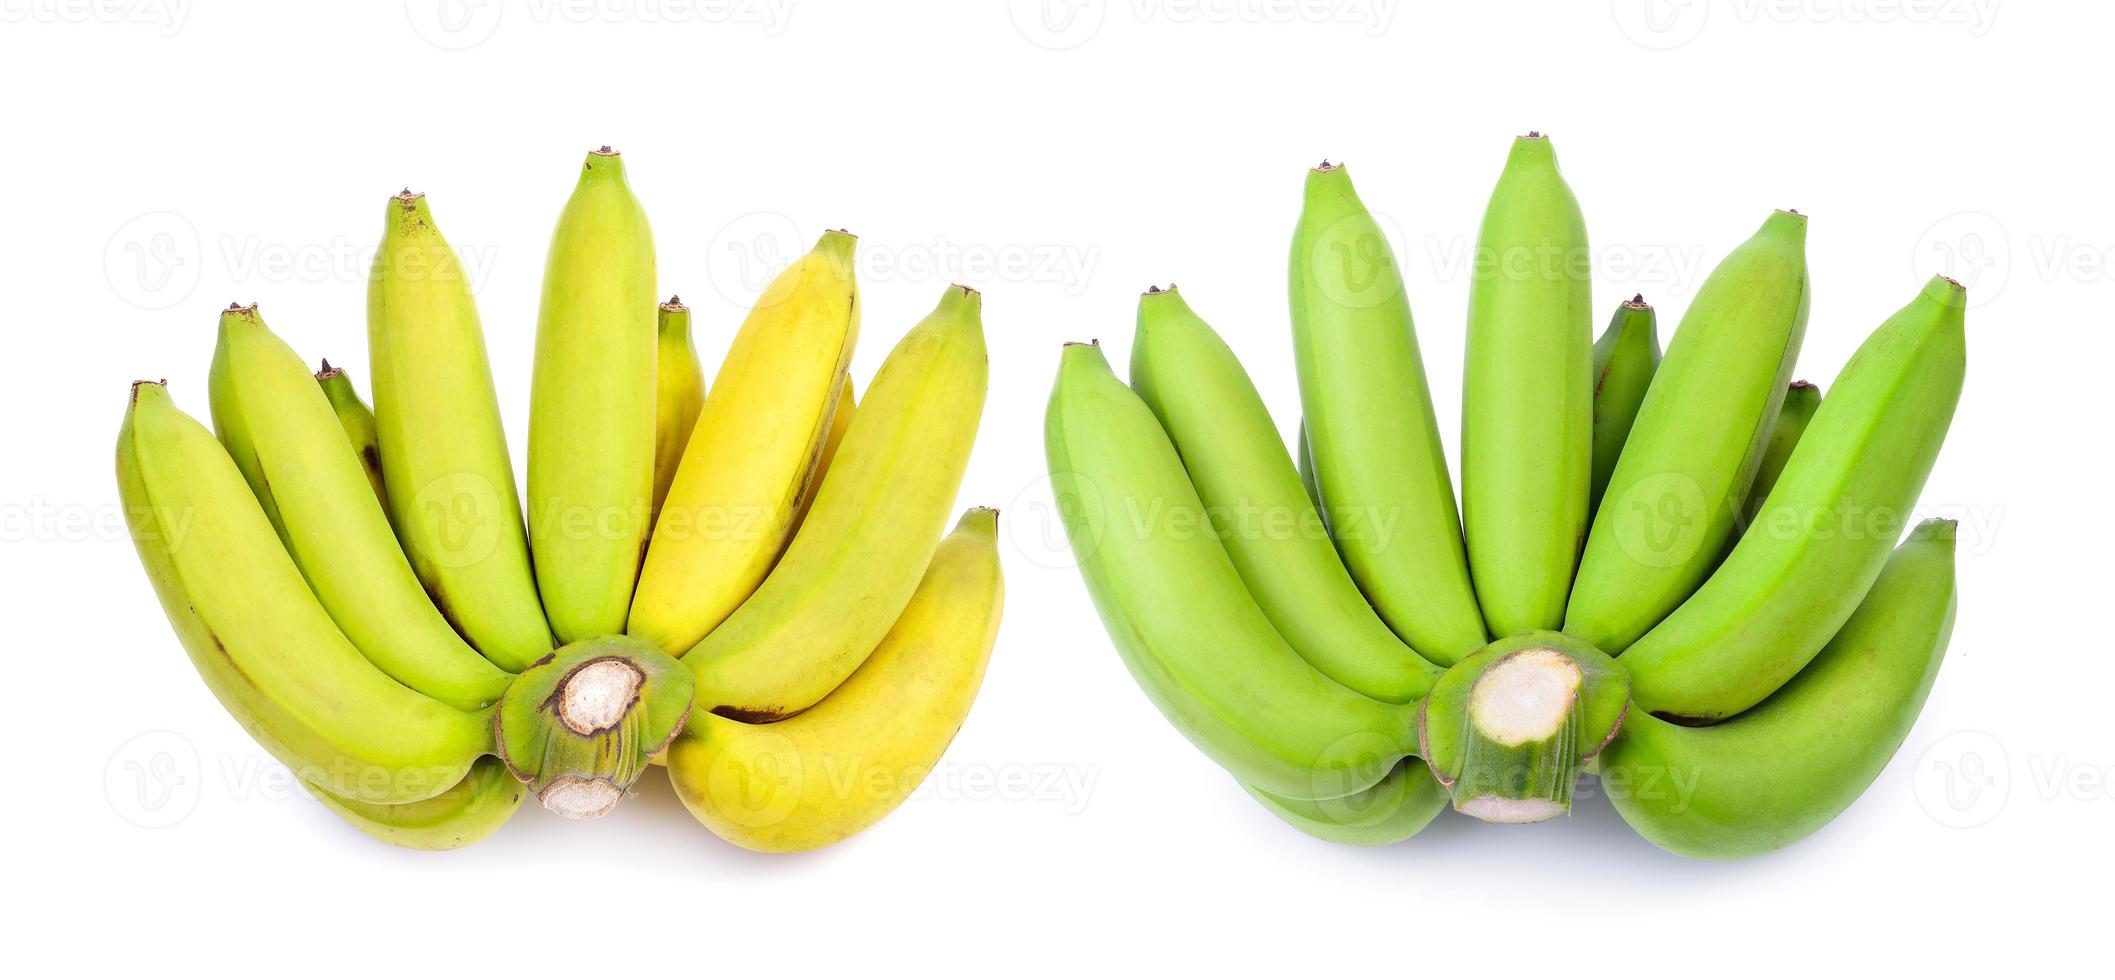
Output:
1288,163,1487,665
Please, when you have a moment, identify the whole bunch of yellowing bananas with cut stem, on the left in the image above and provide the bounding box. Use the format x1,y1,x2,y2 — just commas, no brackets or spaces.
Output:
116,146,1003,851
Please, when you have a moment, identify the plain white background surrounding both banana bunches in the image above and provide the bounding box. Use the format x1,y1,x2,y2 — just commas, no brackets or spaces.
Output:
0,0,2115,976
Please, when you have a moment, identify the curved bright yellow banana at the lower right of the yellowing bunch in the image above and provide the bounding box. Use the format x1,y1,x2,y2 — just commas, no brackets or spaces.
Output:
668,508,1005,851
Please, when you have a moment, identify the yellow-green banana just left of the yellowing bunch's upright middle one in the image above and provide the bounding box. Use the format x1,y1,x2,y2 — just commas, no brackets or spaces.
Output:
368,190,552,671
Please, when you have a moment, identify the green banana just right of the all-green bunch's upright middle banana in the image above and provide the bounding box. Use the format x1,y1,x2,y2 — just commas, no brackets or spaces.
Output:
1565,212,1808,654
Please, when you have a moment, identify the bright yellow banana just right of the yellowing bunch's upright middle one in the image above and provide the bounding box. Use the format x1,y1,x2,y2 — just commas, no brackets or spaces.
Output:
628,231,859,656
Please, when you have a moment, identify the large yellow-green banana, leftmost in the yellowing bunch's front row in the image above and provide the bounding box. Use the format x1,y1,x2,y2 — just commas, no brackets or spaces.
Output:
116,381,493,804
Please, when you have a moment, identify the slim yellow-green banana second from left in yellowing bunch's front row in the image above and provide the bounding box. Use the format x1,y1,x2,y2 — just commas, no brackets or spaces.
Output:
212,307,512,709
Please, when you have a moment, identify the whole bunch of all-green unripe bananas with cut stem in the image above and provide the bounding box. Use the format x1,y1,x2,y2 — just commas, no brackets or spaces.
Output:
1045,133,1965,857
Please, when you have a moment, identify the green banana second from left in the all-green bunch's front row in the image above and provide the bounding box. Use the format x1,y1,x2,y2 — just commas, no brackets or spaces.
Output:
1132,286,1440,705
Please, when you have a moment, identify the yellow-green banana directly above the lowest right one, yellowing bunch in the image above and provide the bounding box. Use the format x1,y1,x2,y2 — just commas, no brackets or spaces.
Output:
677,286,988,722
